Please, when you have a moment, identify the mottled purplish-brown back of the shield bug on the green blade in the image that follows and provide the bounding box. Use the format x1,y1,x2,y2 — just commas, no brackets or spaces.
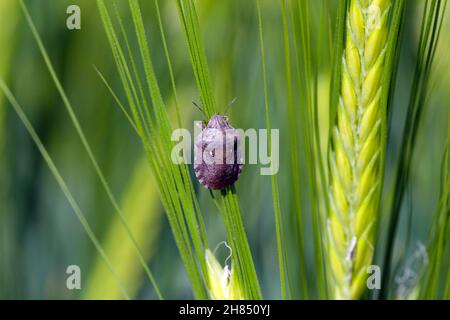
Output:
194,115,243,190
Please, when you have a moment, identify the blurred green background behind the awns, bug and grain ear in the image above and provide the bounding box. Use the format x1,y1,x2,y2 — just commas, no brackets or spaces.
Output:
0,0,450,299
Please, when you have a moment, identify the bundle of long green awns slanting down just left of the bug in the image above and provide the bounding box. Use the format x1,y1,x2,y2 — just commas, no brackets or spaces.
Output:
97,0,207,299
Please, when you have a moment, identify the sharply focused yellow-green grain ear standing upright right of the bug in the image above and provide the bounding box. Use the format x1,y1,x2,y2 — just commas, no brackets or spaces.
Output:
327,0,391,299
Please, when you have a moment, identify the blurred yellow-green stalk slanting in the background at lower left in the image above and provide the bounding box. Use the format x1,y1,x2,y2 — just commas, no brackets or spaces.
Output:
82,157,162,300
